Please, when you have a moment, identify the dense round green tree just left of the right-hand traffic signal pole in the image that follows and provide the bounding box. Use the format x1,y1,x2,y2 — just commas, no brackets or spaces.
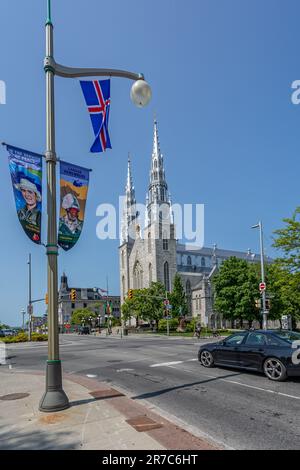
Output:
213,256,259,327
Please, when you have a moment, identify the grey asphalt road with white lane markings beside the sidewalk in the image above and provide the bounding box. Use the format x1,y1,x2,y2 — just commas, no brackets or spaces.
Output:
4,335,300,449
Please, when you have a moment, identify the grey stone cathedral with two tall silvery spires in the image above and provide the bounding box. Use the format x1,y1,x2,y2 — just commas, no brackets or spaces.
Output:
119,120,272,328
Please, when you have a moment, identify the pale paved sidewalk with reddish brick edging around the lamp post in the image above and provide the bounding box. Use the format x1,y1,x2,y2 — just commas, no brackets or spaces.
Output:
0,366,218,450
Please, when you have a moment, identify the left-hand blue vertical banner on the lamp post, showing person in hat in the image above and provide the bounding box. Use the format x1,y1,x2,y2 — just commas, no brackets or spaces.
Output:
6,145,42,244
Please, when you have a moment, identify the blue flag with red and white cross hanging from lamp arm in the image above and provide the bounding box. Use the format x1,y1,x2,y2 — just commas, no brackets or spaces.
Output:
80,80,111,153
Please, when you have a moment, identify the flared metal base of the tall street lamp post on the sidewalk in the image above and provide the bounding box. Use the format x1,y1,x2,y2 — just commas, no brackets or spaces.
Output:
39,361,70,413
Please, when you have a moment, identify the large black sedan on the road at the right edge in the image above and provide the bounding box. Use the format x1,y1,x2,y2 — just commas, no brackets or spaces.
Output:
198,330,300,381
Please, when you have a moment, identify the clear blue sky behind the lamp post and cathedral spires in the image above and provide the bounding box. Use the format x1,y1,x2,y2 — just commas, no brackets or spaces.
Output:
0,0,300,324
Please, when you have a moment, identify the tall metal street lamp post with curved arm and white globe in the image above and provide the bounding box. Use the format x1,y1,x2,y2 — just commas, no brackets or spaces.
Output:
39,0,151,412
